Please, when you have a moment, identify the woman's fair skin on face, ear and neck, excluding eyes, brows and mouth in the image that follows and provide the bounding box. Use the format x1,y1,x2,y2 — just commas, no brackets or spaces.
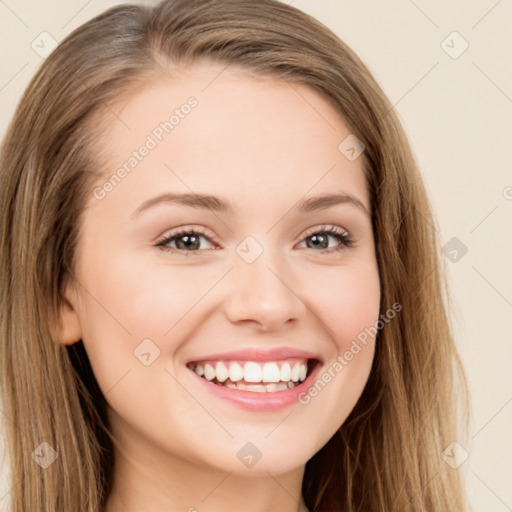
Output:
57,63,380,512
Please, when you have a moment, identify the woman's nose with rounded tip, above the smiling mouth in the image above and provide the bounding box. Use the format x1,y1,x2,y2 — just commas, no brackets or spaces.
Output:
225,247,306,331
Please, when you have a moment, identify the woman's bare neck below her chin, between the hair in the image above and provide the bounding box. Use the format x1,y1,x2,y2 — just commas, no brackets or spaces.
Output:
105,412,308,512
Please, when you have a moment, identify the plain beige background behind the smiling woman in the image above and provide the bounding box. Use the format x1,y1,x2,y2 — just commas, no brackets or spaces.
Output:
0,0,512,512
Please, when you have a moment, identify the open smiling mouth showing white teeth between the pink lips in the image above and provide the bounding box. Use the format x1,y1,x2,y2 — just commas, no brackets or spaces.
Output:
187,357,320,393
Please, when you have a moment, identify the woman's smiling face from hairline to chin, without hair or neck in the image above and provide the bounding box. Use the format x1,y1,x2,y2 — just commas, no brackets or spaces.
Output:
61,65,380,475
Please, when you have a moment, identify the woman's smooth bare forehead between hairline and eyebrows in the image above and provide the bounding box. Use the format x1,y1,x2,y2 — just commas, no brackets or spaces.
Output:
87,64,370,218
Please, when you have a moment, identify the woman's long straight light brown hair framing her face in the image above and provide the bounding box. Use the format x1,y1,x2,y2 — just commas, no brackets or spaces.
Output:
0,0,467,512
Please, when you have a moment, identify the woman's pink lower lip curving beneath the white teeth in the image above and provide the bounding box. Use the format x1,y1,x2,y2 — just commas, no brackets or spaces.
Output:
188,362,321,411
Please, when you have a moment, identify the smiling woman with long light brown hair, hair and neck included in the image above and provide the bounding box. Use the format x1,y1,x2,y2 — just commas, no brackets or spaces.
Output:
0,0,465,512
